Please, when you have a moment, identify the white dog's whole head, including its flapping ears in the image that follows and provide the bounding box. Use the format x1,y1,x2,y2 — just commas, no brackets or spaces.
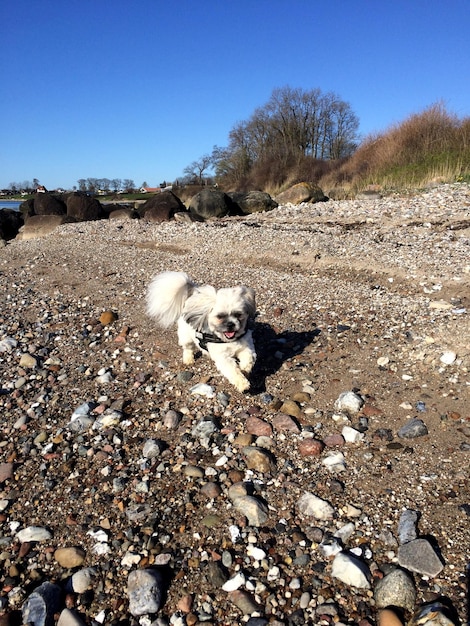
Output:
183,285,256,342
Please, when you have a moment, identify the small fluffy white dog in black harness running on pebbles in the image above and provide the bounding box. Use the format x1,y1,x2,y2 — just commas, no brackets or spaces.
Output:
147,272,256,391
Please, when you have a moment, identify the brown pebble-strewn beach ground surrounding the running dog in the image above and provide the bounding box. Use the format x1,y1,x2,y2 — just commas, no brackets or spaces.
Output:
0,184,470,626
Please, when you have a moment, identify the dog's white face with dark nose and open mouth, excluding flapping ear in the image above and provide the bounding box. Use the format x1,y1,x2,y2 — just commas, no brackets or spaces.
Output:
207,287,256,342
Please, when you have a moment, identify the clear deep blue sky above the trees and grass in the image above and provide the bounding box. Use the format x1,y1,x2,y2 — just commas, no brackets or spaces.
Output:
0,0,470,189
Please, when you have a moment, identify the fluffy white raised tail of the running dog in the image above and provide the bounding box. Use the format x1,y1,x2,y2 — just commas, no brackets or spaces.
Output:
147,272,195,328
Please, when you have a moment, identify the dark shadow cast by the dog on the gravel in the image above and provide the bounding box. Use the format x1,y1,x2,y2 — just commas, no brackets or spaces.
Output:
250,322,321,394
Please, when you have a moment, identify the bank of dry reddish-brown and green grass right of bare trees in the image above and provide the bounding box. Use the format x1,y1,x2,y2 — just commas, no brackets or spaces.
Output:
255,103,470,198
